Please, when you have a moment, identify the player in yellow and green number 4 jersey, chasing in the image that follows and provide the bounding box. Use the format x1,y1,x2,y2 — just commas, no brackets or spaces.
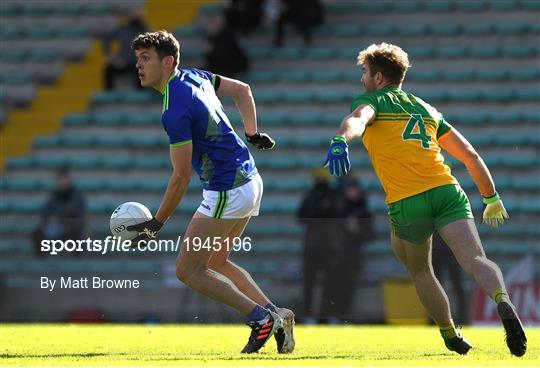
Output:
325,43,527,356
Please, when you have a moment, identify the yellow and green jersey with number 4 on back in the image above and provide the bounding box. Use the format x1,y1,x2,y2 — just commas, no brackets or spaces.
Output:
351,87,458,203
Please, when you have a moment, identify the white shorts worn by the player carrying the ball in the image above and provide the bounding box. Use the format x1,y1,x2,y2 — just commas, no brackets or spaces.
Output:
197,174,263,219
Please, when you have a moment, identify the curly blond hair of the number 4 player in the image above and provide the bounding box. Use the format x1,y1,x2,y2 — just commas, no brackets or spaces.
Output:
357,42,411,84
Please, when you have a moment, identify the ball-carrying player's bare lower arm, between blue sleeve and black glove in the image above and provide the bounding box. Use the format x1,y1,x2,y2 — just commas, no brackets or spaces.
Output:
156,143,193,223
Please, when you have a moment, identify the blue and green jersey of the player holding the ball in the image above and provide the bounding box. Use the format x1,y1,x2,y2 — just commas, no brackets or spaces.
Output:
162,69,257,191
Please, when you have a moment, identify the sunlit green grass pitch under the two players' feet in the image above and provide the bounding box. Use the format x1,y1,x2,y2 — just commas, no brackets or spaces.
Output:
0,324,540,366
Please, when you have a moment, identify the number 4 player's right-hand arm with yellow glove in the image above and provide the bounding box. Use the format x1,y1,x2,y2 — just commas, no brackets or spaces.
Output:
439,128,508,227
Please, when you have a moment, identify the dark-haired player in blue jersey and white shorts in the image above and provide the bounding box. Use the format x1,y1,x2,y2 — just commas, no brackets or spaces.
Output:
130,31,294,353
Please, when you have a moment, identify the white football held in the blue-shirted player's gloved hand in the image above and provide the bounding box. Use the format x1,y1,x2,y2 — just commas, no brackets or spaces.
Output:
110,202,152,240
